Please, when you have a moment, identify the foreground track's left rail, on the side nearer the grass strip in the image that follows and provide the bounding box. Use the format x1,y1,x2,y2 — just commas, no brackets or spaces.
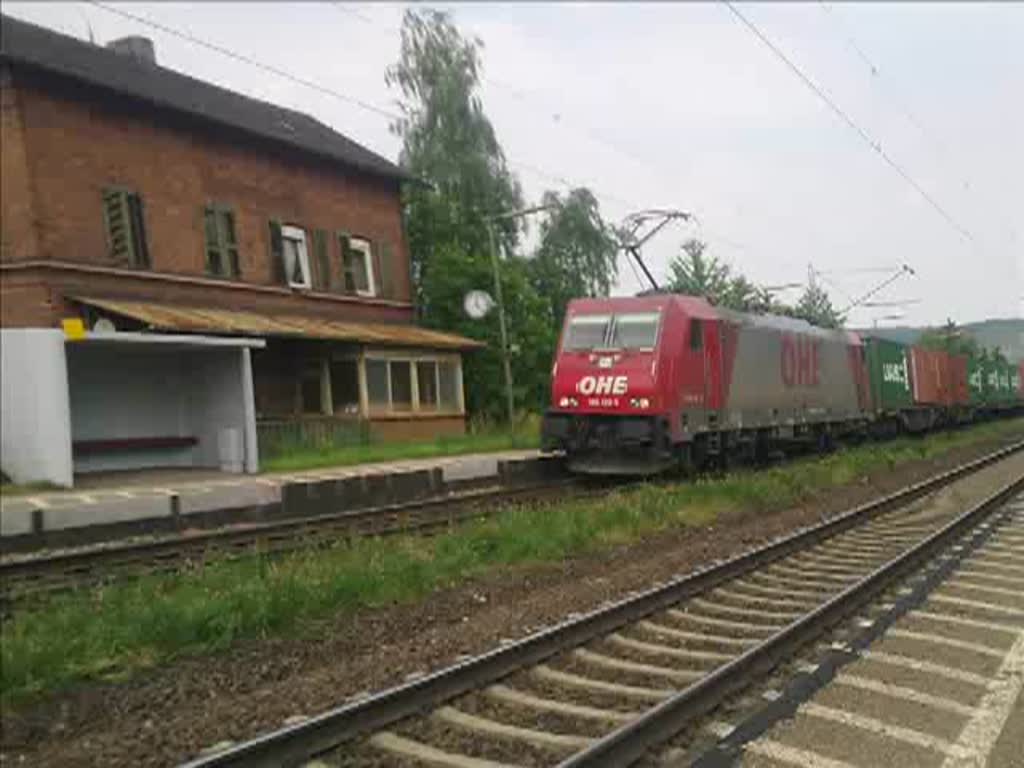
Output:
183,441,1024,768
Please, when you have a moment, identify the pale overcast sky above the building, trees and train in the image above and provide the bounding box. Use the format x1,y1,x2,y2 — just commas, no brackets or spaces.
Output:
3,2,1024,325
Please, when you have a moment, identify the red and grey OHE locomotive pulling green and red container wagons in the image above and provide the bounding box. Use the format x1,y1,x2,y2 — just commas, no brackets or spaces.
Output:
542,294,1024,474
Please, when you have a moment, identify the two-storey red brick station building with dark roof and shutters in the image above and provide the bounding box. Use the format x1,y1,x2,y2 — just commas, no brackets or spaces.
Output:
0,16,475,483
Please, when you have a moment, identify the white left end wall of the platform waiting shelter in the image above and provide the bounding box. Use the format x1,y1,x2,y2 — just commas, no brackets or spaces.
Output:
0,328,74,487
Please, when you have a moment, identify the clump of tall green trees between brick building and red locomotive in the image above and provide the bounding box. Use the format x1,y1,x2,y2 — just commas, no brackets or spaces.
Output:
386,8,615,417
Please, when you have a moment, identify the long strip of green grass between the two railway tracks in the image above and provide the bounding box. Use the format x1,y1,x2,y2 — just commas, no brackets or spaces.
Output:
0,419,1024,703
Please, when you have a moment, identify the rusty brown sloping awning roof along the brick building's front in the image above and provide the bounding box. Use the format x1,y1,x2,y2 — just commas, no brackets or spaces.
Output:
73,296,484,349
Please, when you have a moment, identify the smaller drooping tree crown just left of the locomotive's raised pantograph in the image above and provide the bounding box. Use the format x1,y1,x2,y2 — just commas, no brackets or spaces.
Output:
529,187,618,329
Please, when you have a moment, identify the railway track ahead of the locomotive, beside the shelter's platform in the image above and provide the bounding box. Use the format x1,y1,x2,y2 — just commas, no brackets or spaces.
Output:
0,479,585,605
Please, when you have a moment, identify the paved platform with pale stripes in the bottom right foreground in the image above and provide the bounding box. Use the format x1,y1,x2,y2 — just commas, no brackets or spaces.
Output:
679,487,1024,768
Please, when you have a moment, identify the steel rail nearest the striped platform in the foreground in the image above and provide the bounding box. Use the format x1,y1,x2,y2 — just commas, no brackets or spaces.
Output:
558,466,1024,768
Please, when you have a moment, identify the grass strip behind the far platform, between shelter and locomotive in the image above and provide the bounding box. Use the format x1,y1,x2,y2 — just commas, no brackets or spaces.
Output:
260,419,541,472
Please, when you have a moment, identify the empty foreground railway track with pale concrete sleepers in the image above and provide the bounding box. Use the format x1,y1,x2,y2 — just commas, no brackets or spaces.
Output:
180,443,1024,768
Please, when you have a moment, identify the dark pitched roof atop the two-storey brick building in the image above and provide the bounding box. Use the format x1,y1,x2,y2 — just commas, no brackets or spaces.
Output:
0,15,412,185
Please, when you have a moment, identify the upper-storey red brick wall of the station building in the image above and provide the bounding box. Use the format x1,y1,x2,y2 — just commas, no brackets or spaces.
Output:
2,70,411,317
